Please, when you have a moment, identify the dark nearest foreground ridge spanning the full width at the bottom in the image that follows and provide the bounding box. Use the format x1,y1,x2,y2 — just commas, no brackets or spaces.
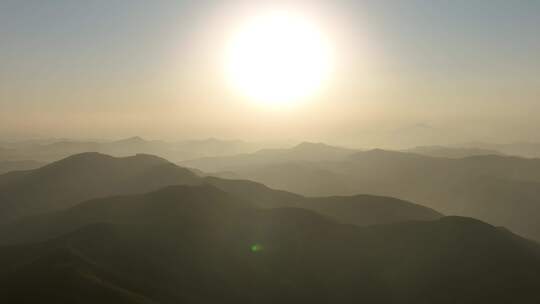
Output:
0,185,540,304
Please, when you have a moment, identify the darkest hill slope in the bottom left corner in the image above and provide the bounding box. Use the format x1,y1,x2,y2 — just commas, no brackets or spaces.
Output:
0,247,156,304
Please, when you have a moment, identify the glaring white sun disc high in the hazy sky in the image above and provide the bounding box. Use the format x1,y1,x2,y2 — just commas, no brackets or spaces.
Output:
226,11,332,105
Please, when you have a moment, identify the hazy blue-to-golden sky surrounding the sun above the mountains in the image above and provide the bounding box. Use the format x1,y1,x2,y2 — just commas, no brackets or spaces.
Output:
0,0,540,145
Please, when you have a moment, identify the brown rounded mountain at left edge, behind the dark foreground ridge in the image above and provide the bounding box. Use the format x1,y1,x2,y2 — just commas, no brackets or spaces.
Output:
0,153,199,222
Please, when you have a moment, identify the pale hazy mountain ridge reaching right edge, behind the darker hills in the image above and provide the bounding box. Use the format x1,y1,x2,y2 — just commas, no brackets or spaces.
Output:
189,149,540,240
